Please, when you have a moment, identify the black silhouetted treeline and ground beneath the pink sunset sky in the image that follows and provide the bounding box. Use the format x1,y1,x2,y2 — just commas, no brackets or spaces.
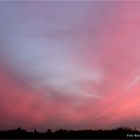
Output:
0,127,140,139
